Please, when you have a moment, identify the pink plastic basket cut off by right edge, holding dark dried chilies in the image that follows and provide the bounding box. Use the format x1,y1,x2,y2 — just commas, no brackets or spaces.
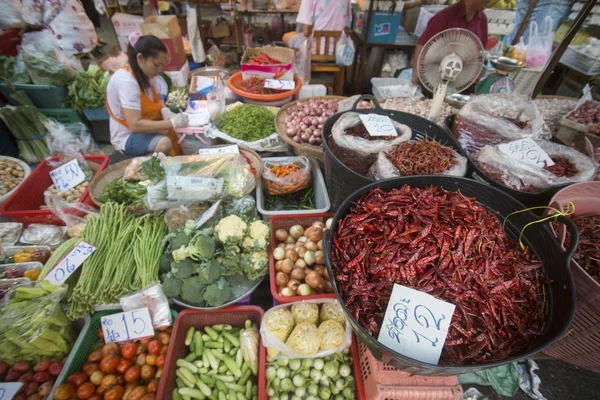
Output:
544,181,600,373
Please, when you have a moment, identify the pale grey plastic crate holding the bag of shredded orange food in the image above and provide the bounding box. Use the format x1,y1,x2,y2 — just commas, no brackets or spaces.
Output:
256,157,331,220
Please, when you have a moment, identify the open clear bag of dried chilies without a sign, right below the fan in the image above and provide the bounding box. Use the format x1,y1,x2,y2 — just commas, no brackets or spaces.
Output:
452,93,549,154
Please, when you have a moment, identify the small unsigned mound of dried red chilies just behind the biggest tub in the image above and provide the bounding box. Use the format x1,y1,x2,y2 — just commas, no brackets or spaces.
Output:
385,139,456,176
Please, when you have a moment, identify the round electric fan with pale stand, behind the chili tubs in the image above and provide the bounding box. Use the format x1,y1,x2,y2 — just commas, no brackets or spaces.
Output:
417,28,483,122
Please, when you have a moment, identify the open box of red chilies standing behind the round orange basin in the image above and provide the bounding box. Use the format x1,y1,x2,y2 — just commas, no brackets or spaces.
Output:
242,46,294,81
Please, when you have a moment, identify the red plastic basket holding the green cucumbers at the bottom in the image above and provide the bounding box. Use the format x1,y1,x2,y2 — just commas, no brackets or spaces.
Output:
156,306,266,400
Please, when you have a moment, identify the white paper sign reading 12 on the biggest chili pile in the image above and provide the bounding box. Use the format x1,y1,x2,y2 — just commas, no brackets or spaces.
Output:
377,284,455,364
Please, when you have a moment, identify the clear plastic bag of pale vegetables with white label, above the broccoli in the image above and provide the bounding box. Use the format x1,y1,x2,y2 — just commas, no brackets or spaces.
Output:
164,153,256,203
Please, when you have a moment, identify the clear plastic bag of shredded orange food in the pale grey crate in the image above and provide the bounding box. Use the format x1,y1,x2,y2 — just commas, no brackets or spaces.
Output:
262,157,312,195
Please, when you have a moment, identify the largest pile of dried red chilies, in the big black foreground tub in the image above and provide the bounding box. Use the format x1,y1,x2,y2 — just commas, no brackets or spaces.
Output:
331,185,545,365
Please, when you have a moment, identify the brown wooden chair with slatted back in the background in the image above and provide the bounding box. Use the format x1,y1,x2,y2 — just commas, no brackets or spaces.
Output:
310,31,346,96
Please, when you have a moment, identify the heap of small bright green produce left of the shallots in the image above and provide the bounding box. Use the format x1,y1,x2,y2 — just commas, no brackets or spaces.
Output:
215,104,275,142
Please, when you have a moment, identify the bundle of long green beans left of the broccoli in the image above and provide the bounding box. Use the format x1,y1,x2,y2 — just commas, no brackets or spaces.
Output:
67,202,166,319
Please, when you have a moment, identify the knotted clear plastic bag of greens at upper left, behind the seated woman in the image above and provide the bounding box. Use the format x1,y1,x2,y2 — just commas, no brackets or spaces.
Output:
21,29,83,86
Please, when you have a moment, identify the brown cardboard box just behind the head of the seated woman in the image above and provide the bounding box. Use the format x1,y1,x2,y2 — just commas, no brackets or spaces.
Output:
140,15,187,71
